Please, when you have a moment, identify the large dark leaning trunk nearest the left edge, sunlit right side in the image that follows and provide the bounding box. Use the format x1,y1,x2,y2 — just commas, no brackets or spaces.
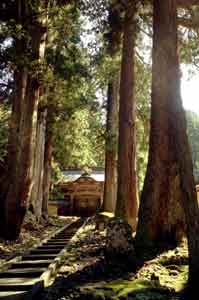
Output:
4,1,47,240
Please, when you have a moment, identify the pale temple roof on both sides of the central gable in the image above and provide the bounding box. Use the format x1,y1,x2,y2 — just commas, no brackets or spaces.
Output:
63,168,104,182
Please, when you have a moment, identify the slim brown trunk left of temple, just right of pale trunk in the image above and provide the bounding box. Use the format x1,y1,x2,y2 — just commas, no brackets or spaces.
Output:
42,132,53,218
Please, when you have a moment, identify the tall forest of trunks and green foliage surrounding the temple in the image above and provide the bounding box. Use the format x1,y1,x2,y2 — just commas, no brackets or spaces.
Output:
0,0,199,296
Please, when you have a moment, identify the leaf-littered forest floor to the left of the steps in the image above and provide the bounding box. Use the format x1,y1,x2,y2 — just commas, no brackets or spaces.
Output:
0,213,75,268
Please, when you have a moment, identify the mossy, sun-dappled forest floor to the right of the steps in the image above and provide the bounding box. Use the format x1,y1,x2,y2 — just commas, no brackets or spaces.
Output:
40,218,188,300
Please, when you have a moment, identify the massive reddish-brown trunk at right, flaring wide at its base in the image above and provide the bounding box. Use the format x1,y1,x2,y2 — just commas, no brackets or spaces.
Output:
136,0,185,248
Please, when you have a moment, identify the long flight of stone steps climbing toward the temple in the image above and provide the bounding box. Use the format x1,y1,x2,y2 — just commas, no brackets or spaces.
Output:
0,220,83,300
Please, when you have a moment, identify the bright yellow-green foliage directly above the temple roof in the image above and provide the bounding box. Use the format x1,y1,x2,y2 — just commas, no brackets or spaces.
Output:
54,109,104,169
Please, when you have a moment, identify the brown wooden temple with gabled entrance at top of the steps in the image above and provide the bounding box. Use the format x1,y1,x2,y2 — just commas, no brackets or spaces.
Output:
49,168,104,216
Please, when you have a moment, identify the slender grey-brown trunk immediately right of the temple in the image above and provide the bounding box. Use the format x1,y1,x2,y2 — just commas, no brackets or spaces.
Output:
104,74,119,212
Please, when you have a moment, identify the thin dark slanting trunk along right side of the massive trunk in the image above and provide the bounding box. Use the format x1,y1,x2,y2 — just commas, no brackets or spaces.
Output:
164,0,199,292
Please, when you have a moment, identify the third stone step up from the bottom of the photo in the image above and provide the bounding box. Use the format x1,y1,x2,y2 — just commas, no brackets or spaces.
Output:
0,268,46,278
